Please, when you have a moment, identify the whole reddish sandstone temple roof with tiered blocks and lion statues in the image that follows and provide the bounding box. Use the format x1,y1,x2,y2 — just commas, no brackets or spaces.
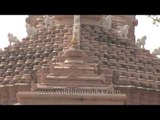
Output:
0,15,160,105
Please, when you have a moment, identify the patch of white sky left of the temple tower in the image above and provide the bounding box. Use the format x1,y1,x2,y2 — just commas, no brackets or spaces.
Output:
0,15,28,48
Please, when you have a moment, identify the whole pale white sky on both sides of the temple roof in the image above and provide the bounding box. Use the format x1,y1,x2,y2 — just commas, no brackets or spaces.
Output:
0,15,160,52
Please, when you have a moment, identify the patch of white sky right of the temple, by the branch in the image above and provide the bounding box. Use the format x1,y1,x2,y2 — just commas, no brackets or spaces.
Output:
135,15,160,52
